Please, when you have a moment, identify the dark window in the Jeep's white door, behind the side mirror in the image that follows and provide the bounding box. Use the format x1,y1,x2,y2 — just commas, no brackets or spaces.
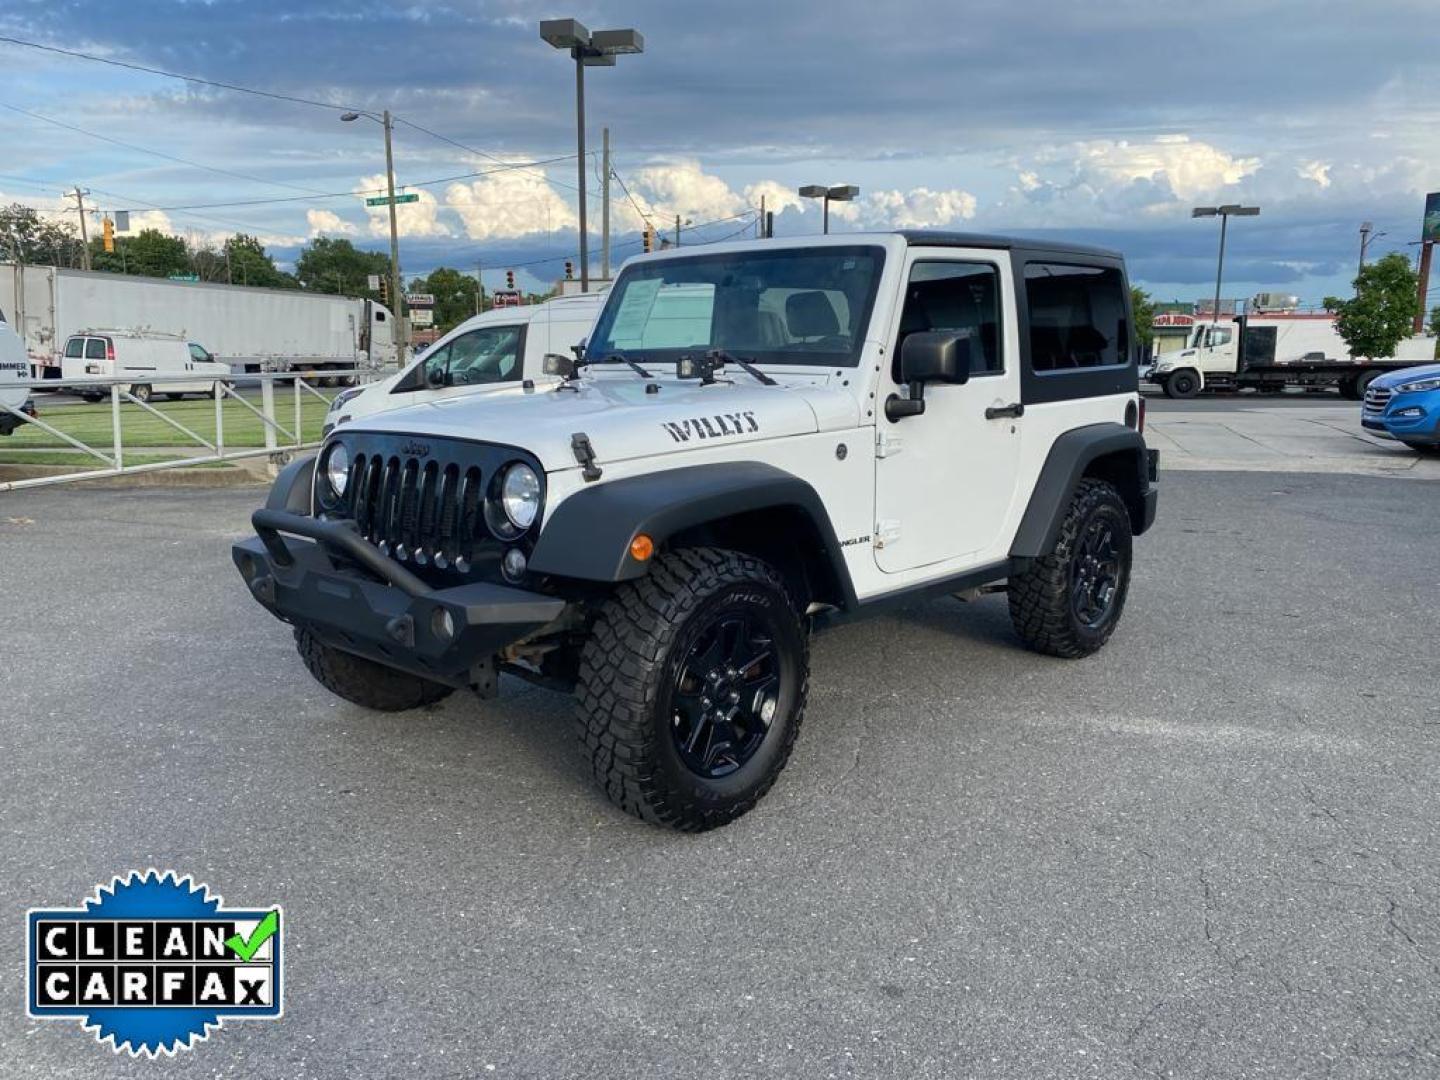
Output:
890,261,1005,382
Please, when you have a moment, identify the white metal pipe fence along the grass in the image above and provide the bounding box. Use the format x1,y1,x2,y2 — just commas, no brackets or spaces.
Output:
0,369,360,491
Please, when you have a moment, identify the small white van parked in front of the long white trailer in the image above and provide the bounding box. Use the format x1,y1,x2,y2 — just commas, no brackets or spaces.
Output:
60,330,230,402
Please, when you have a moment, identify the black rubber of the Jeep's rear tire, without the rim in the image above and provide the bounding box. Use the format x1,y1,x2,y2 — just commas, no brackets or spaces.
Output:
1007,480,1133,660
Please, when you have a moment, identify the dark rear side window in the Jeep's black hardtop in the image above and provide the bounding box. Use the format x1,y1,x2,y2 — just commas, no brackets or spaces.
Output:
1025,262,1130,373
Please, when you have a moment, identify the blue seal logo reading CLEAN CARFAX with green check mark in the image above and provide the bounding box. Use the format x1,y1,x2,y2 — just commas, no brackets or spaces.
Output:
26,870,284,1057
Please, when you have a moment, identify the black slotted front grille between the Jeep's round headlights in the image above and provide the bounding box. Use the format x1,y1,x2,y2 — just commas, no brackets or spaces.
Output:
346,454,490,573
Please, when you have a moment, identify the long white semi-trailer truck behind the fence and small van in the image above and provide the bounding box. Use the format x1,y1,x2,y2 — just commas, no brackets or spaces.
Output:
0,262,396,384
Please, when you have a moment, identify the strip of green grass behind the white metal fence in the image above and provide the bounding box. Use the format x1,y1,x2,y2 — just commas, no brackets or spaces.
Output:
12,386,328,461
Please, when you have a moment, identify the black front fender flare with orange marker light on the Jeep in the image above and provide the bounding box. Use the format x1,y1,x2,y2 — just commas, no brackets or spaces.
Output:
530,461,854,603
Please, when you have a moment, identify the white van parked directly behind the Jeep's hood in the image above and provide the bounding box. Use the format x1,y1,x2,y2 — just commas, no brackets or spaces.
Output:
324,292,605,435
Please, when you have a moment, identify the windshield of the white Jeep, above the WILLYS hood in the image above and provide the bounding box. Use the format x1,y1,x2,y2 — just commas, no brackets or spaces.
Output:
586,246,884,367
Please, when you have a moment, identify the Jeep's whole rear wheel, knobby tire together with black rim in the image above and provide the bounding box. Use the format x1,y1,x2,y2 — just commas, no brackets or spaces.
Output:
1008,480,1133,660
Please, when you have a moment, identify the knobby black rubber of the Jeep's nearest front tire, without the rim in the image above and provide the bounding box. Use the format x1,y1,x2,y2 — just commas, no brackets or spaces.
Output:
576,547,809,832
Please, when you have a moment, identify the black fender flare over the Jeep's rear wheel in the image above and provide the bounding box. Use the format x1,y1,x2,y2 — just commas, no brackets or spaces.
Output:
1009,423,1153,559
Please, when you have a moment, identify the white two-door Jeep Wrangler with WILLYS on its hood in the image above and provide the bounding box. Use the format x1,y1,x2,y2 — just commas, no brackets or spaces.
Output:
233,232,1156,829
